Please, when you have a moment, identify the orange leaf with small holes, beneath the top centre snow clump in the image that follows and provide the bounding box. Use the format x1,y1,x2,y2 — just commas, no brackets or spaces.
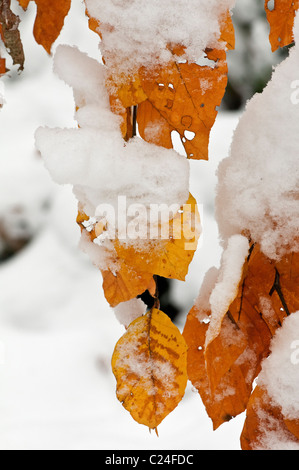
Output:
137,50,227,160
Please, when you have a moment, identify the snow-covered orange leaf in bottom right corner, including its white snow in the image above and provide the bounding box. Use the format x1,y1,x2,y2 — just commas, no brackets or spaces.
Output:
241,311,299,450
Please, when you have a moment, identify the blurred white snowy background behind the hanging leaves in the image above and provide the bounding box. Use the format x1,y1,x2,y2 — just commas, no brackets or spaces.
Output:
0,1,282,450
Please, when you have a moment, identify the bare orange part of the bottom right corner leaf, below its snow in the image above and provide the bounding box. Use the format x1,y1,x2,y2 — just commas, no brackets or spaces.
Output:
241,386,299,450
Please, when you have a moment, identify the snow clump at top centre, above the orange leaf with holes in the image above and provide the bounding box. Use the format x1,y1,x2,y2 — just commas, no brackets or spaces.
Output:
86,0,235,75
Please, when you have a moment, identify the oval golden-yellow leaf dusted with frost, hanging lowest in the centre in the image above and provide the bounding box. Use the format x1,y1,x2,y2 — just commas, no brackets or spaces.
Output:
112,309,187,430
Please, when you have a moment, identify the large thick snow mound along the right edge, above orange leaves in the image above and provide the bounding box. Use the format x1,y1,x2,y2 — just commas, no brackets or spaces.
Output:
216,15,299,260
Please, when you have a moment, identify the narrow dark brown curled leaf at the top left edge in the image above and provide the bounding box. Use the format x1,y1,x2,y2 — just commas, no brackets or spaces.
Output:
0,0,25,70
